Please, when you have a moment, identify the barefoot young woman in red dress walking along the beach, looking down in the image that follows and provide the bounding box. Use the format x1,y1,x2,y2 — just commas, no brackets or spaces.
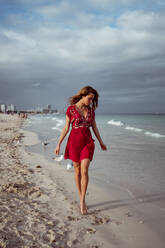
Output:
55,86,107,214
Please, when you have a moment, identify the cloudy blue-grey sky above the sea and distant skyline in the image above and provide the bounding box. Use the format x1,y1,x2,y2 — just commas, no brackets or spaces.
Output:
0,0,165,113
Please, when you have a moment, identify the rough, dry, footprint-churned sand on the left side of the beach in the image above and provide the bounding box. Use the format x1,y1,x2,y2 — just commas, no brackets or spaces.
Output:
0,115,112,248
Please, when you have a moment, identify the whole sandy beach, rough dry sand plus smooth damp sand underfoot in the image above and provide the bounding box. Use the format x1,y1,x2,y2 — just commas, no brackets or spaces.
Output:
0,114,164,248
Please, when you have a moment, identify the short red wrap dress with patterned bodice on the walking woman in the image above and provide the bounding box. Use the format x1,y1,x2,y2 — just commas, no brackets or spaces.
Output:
64,105,95,163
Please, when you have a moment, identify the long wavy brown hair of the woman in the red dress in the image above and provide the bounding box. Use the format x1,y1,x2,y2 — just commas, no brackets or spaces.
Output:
69,86,99,109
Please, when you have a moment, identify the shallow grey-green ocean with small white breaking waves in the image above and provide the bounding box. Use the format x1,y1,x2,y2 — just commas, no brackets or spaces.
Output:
25,114,165,206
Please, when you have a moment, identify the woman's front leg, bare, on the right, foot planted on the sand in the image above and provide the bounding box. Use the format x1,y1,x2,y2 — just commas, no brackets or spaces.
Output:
80,158,90,214
